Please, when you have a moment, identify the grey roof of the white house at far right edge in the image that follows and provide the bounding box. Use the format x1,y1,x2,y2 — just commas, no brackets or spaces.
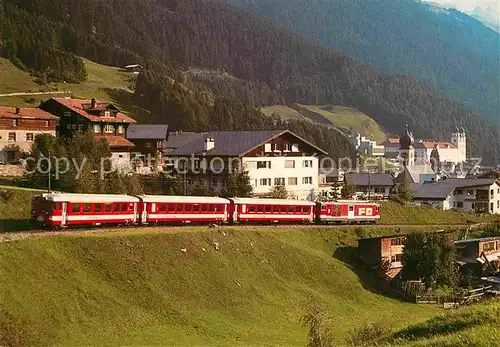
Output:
413,178,495,200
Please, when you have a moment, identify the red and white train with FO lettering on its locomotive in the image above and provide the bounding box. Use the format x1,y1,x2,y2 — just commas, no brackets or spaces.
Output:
31,193,380,227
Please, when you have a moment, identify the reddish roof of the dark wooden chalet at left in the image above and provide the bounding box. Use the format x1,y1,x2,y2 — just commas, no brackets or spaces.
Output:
52,98,136,123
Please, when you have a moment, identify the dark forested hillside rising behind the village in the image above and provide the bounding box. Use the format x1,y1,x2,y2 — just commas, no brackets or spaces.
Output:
0,0,500,163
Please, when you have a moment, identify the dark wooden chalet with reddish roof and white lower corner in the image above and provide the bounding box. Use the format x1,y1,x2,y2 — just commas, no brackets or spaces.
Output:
40,98,136,167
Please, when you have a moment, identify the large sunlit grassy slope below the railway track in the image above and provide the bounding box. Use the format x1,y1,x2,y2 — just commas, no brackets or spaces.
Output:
0,227,439,346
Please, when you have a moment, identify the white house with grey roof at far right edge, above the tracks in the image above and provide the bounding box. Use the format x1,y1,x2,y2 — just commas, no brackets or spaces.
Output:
413,178,500,214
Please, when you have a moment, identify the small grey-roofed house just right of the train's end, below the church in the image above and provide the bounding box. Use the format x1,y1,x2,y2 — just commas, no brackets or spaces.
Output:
344,172,394,199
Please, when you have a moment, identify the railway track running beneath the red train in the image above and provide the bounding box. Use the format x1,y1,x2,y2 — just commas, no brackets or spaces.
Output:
0,224,474,243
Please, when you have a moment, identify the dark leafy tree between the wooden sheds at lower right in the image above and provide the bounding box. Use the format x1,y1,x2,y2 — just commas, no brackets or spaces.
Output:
401,232,458,288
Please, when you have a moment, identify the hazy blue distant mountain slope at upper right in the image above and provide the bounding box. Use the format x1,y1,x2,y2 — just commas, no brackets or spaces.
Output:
233,0,500,123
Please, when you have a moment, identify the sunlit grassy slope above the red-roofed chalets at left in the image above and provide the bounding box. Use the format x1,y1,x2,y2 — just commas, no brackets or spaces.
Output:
0,58,147,121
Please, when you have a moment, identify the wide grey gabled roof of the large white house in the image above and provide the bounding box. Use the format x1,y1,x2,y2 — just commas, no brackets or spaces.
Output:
170,130,327,156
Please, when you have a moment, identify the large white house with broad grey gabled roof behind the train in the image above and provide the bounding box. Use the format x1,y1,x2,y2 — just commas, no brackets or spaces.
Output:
167,130,327,199
